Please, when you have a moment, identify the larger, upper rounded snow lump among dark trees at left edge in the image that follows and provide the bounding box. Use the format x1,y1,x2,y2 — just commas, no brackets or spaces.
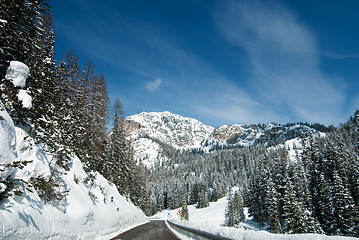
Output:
5,61,30,88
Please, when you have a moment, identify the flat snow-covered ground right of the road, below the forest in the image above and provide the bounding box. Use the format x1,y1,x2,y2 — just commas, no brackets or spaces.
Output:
153,197,359,240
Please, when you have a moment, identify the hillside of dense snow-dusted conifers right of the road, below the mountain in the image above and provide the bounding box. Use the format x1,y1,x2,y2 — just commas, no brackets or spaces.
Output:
143,112,359,236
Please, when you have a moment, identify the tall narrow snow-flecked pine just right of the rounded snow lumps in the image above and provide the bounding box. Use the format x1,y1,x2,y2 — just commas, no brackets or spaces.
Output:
29,10,63,152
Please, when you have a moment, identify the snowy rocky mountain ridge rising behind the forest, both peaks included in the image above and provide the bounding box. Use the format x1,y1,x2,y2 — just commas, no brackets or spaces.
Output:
123,111,318,167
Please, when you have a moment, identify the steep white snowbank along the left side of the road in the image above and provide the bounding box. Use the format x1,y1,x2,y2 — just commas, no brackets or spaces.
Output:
0,106,147,239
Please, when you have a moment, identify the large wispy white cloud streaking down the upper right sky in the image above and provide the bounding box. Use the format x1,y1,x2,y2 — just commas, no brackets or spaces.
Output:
217,1,344,124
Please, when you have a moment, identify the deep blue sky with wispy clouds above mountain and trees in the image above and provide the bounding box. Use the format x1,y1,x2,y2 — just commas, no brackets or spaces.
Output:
51,0,359,126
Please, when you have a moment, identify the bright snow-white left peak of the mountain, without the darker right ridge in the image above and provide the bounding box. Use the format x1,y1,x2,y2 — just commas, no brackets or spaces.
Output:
124,112,214,167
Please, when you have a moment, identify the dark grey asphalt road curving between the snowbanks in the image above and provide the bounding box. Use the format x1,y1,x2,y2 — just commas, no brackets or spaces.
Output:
112,221,179,240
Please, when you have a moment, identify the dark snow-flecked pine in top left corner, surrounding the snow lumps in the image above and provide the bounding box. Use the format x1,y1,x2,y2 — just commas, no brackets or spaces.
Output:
0,0,49,124
